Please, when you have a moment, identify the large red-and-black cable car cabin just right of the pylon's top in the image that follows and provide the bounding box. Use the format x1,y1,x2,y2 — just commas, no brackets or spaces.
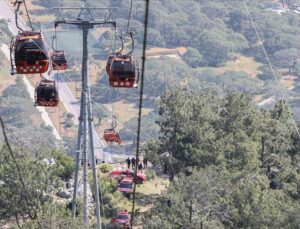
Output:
108,55,139,87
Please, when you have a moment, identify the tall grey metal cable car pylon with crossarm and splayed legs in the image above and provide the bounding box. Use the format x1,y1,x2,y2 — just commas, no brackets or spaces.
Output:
55,7,116,229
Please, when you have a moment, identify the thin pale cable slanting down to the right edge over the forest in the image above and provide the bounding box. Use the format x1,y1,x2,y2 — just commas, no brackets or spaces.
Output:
243,0,300,139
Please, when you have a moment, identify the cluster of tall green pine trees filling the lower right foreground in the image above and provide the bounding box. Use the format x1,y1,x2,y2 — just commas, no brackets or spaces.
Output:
145,88,300,228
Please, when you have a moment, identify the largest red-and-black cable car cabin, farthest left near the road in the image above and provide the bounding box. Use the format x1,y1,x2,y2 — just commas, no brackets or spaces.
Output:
11,31,49,74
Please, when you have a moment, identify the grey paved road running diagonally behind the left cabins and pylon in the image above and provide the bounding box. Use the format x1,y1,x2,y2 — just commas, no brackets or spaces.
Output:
0,0,112,162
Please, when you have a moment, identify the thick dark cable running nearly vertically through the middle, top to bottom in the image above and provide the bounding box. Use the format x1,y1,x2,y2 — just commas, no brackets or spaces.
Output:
131,0,150,228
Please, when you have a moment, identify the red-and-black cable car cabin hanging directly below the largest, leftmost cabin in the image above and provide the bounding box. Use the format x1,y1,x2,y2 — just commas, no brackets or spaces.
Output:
35,80,59,107
